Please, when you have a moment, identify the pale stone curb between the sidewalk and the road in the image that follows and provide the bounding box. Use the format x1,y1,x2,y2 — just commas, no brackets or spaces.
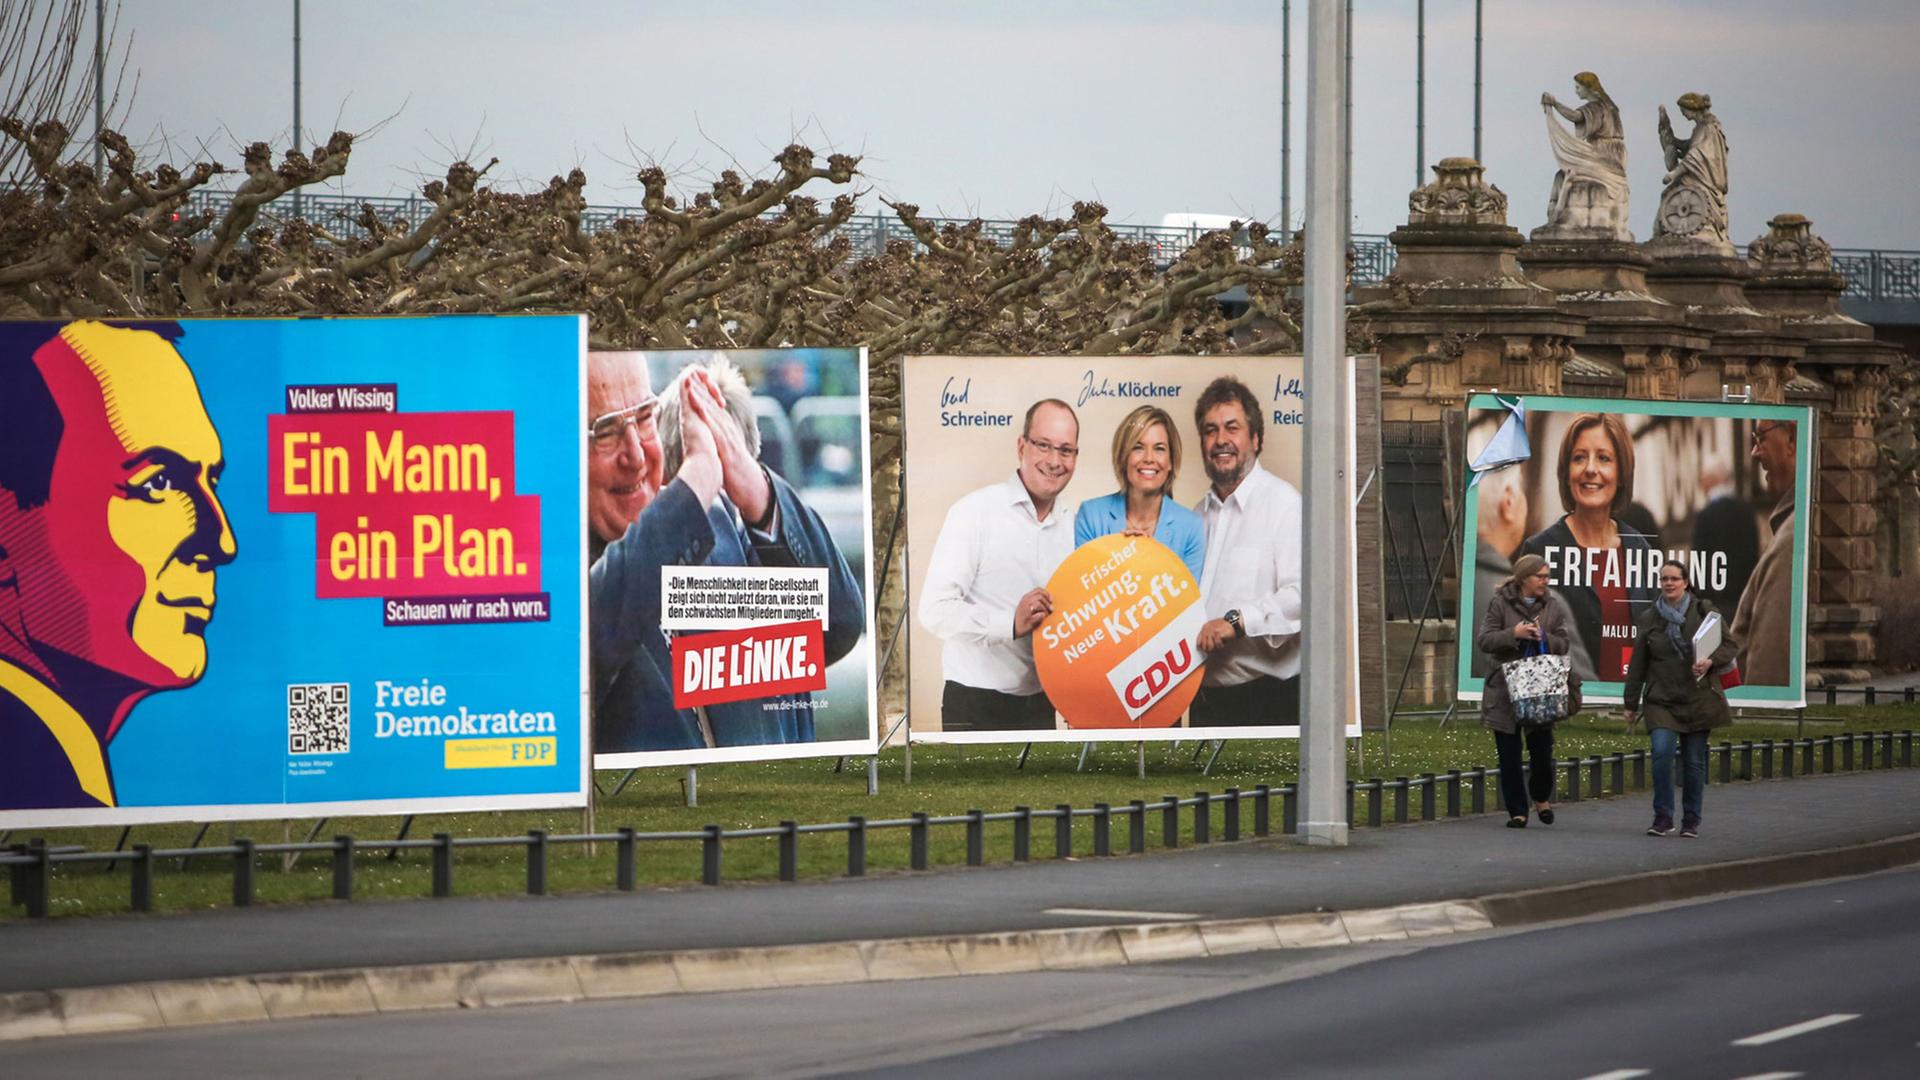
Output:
0,834,1920,1042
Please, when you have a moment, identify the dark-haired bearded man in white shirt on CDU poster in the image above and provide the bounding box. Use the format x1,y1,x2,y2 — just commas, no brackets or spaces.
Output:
1187,375,1302,728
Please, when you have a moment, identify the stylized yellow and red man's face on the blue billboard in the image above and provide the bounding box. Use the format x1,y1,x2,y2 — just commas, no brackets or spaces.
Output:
12,323,234,690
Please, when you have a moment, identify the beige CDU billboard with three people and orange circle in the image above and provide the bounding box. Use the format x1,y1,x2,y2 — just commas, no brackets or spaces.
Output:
900,356,1359,742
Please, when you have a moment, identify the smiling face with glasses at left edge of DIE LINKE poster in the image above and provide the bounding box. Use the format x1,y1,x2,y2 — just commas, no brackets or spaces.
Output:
588,352,666,544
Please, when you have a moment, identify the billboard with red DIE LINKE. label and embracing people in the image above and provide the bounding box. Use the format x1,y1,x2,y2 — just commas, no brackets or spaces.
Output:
586,348,877,769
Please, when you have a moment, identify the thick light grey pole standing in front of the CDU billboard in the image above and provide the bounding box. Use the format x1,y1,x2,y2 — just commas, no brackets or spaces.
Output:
1298,0,1354,846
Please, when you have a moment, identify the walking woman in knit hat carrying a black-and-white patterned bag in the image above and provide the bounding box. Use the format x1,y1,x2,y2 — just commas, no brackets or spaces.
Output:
1475,555,1572,828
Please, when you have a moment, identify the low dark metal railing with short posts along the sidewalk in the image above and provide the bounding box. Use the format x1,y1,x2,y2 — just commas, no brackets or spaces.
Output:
0,728,1914,919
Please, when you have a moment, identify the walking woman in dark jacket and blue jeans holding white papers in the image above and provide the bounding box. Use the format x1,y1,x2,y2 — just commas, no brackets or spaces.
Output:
1626,559,1740,836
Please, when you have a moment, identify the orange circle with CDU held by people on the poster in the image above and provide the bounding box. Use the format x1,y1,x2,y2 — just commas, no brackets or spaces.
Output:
1033,536,1206,728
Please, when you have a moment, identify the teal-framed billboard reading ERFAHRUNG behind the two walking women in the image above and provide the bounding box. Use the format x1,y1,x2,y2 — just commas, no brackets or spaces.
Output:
1457,394,1814,705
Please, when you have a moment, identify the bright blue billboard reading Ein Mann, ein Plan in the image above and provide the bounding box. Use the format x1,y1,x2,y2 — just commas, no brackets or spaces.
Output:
0,315,588,828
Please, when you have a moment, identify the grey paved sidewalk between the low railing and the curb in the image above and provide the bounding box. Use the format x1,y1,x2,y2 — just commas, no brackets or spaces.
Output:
0,769,1920,994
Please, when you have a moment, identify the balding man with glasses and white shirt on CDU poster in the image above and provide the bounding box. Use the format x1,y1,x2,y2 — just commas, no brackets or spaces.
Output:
920,398,1079,732
